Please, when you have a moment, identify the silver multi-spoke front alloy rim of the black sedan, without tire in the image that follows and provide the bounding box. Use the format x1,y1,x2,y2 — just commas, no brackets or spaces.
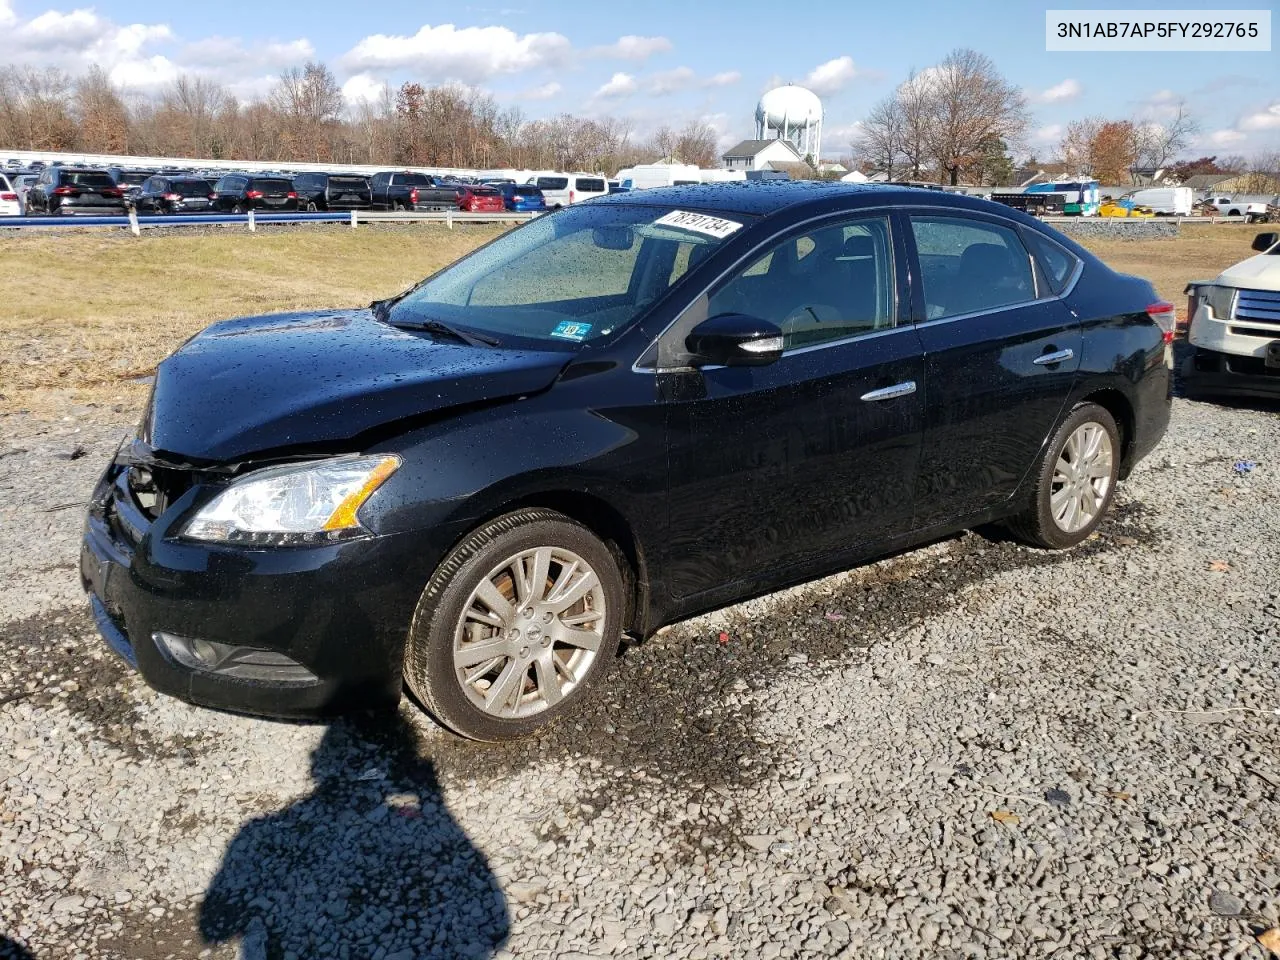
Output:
453,547,607,719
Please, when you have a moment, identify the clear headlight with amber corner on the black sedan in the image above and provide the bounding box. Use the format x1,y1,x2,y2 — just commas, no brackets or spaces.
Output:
182,457,401,545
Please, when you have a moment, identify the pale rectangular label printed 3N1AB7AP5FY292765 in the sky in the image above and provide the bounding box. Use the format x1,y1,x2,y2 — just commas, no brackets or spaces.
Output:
1044,10,1271,52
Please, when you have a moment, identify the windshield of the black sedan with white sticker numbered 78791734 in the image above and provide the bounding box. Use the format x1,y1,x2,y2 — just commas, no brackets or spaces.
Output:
389,204,750,347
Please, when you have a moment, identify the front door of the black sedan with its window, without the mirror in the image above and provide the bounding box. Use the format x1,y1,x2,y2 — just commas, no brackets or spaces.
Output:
659,215,924,596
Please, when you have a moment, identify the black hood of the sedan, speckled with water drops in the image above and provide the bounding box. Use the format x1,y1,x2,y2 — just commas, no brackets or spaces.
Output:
141,310,572,461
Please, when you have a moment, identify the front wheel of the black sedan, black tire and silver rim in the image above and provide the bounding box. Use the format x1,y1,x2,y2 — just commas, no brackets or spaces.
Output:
404,508,625,741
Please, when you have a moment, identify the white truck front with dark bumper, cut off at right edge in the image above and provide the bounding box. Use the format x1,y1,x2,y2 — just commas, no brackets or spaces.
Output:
1179,233,1280,397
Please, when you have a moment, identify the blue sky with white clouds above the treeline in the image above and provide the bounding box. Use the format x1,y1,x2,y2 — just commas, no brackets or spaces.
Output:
0,0,1280,159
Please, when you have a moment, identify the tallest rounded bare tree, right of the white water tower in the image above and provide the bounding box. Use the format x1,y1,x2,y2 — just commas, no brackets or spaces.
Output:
922,49,1028,184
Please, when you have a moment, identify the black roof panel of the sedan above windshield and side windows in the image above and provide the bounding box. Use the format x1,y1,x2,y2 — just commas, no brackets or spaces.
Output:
591,180,1018,218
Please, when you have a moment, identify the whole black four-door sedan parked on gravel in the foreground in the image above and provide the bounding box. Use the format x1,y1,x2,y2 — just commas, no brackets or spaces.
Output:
81,183,1172,740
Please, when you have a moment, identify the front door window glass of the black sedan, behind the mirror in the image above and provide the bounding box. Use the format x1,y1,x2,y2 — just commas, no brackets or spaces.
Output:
708,216,895,349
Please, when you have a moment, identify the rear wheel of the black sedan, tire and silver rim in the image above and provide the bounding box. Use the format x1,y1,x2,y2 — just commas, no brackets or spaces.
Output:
1006,403,1121,550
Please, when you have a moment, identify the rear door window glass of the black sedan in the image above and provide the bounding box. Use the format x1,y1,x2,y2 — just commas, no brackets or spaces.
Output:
911,216,1036,320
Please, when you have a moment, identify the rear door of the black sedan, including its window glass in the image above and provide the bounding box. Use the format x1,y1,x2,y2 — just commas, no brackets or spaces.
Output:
904,210,1082,529
